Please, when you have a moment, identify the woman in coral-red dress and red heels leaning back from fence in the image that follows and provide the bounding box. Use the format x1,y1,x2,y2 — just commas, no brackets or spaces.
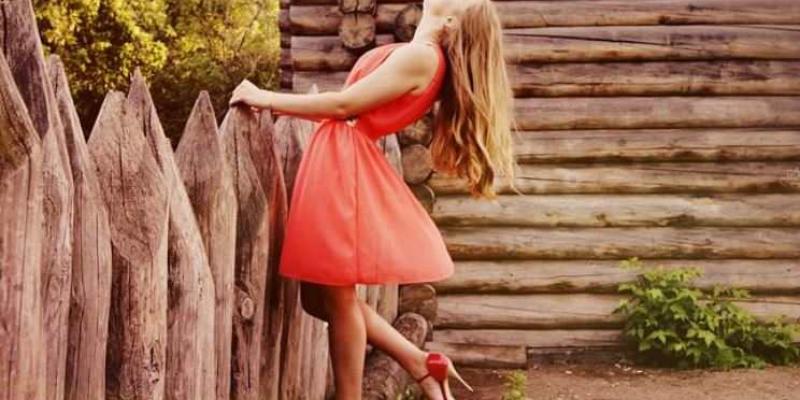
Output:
231,0,514,400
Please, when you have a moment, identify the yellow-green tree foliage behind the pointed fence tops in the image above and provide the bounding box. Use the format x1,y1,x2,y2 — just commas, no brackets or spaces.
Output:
34,0,280,138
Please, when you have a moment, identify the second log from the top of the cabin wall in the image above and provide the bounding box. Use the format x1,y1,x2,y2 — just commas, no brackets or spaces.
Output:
291,25,800,72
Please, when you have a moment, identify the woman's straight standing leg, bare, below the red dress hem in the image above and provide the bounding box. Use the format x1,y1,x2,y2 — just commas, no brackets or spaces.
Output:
323,286,367,400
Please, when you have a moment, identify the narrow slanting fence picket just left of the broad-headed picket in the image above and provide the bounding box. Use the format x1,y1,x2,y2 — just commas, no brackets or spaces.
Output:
48,55,112,400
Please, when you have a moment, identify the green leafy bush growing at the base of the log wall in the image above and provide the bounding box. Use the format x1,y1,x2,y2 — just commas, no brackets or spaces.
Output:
614,258,800,369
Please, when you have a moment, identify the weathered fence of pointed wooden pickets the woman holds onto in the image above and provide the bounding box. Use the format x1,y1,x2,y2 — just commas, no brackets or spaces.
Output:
0,1,429,400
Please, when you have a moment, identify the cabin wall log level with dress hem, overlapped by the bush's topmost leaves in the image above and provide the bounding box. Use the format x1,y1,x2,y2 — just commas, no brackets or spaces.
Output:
434,259,800,295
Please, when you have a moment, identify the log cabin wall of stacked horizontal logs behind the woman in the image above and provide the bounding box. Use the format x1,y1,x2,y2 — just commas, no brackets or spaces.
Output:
281,0,800,366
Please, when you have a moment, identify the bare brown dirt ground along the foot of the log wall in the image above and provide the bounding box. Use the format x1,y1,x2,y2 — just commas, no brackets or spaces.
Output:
451,364,800,400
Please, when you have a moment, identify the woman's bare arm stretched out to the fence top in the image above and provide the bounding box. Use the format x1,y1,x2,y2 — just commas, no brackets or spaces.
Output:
231,44,437,119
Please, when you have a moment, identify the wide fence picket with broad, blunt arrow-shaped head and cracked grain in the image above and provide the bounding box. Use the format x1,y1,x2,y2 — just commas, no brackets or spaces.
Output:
89,92,169,400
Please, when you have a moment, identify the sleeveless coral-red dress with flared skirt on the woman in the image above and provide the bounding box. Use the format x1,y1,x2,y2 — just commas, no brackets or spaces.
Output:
280,43,454,286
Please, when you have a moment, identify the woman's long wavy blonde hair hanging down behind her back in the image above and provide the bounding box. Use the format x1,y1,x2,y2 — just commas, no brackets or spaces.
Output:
431,0,520,199
